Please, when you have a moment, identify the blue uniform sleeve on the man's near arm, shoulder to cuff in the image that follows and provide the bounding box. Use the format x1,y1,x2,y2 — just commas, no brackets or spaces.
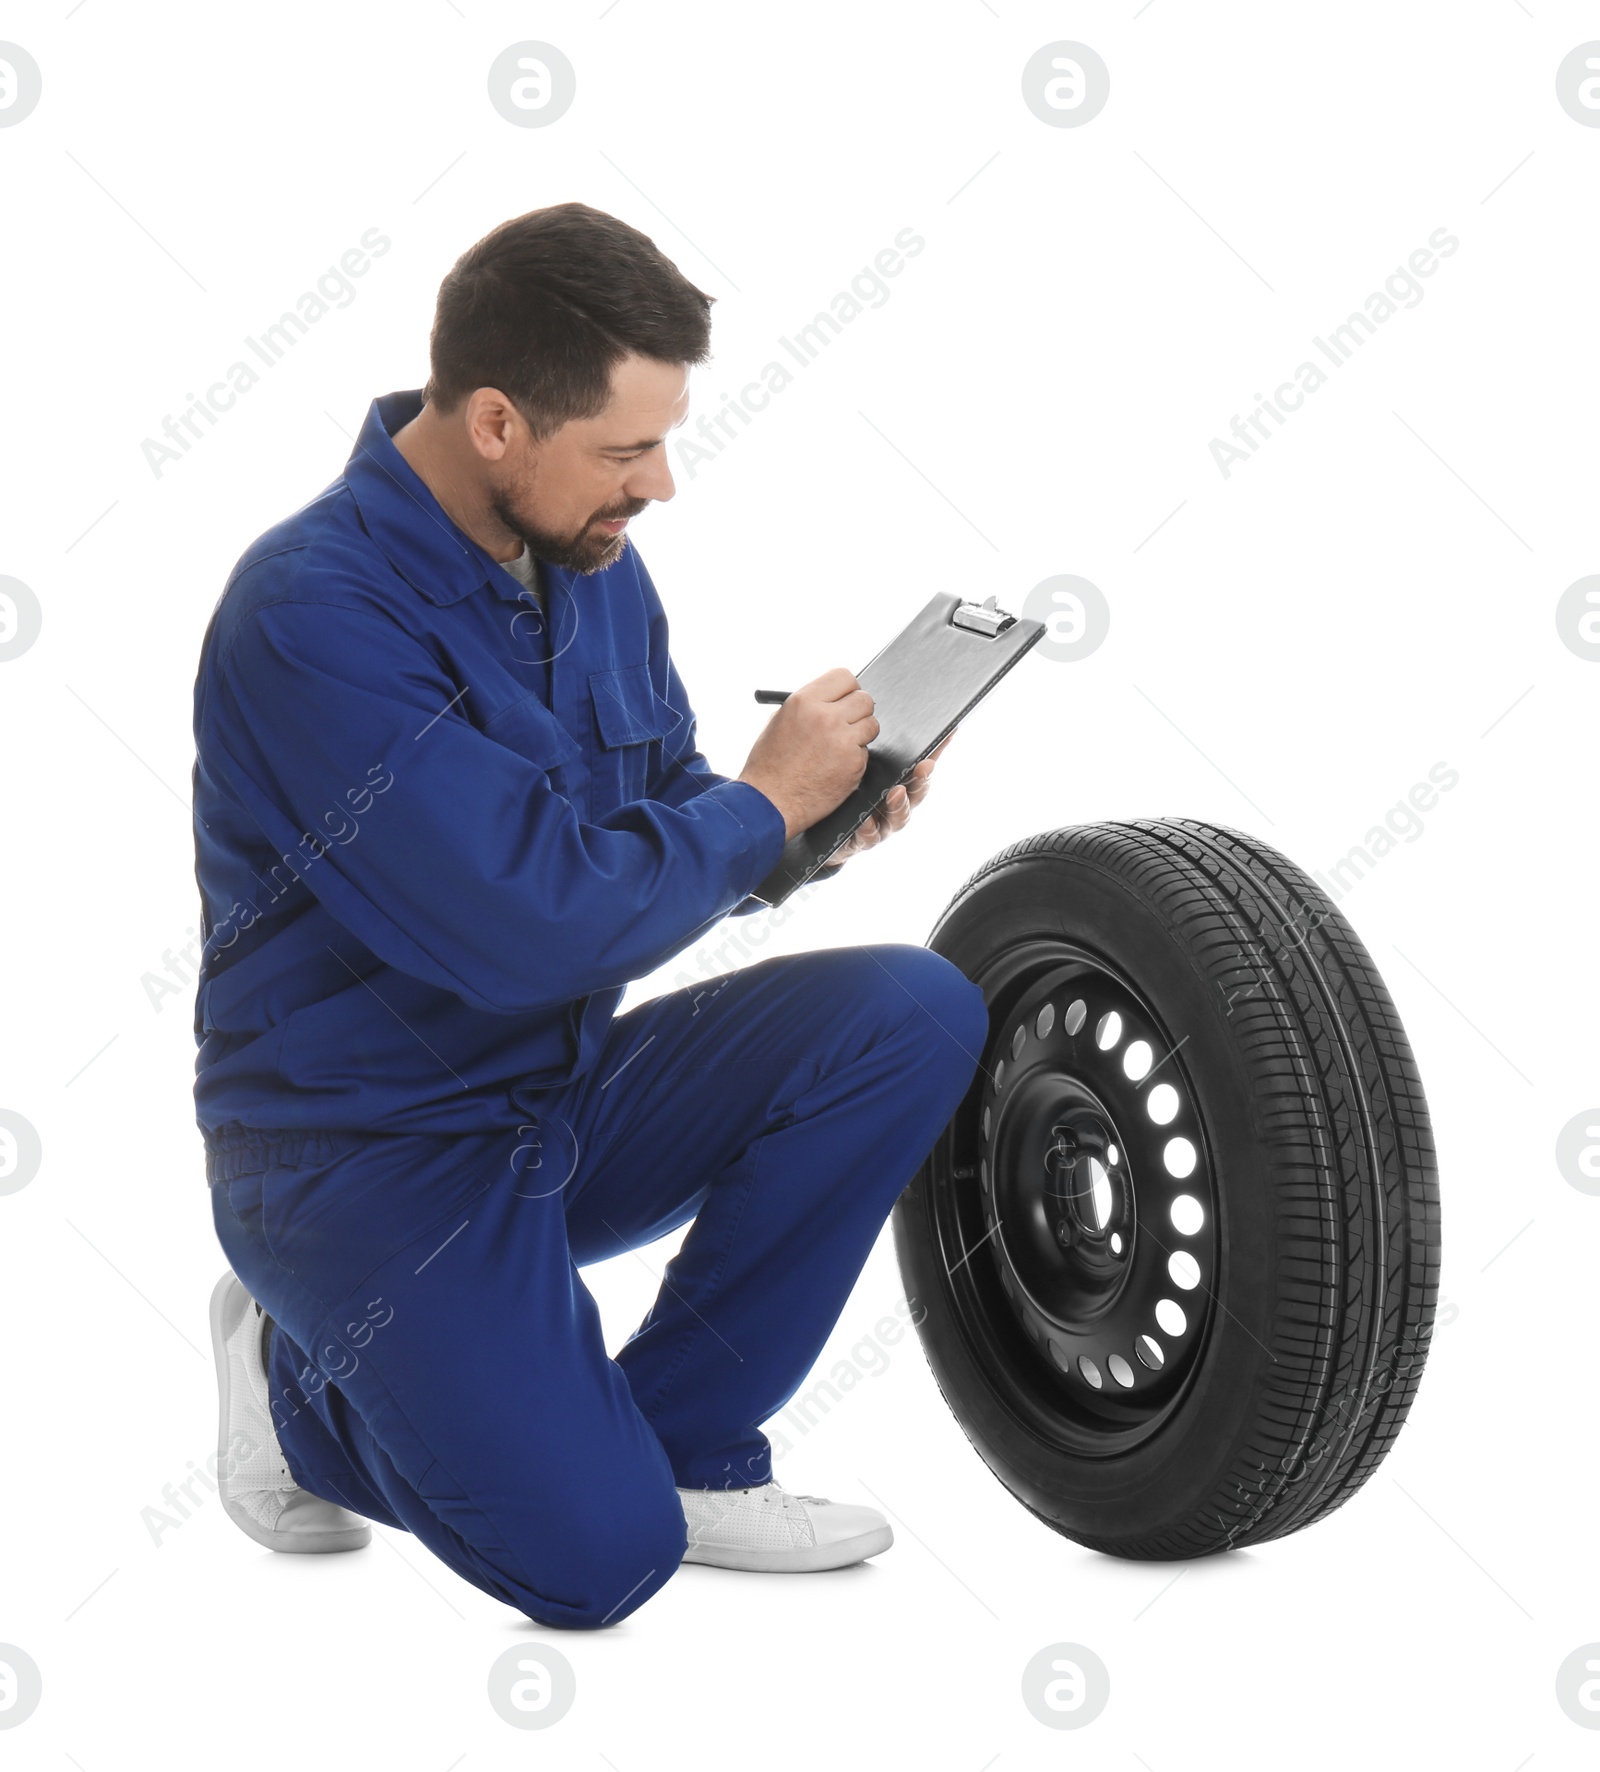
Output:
202,602,785,1014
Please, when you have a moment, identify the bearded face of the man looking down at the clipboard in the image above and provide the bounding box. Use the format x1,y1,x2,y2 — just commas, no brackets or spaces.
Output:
473,356,689,572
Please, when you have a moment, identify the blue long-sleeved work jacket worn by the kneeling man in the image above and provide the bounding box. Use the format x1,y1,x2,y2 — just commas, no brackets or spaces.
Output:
193,390,800,1132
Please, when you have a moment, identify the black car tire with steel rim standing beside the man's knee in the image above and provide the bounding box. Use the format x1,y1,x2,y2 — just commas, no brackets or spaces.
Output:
893,819,1439,1559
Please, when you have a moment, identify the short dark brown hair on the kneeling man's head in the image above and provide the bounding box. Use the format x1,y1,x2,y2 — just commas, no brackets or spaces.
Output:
423,204,716,441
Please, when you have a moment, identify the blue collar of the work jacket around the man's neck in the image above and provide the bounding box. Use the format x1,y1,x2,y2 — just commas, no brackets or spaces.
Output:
344,388,551,606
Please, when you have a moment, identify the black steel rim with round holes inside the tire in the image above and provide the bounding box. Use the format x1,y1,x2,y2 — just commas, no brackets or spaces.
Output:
934,939,1224,1457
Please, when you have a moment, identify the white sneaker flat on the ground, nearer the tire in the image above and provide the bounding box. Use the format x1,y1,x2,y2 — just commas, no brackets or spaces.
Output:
679,1483,895,1575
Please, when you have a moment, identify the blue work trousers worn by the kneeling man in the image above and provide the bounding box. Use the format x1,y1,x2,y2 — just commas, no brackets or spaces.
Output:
207,943,987,1628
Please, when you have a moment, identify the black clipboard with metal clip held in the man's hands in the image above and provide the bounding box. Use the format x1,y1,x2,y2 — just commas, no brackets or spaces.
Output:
751,590,1045,905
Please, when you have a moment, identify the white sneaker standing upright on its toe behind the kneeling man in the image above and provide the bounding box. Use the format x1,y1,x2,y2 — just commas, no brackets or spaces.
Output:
211,1272,372,1551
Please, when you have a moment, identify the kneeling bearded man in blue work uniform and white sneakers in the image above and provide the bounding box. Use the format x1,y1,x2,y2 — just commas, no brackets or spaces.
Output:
195,204,987,1628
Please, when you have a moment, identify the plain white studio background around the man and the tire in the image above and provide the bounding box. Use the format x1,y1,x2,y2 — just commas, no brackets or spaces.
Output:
0,0,1600,1772
